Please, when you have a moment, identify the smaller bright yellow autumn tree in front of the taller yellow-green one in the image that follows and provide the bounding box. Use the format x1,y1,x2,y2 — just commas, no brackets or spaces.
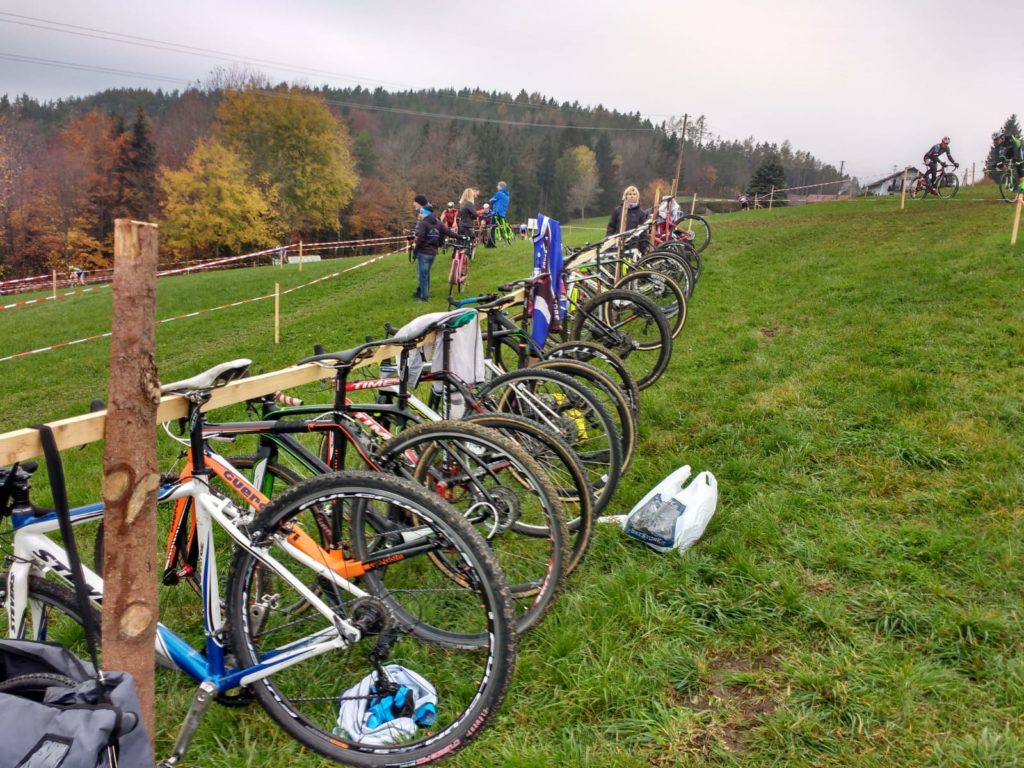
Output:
160,140,276,258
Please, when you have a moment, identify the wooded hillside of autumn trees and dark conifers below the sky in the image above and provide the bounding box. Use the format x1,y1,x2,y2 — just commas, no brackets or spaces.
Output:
0,73,838,276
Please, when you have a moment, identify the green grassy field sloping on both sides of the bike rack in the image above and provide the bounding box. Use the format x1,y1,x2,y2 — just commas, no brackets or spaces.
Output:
0,187,1024,768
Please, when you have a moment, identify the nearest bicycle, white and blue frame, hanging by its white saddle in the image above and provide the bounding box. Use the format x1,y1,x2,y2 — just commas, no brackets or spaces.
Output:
0,360,515,768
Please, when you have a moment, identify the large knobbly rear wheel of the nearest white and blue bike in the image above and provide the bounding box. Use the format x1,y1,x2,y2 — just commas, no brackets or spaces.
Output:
227,472,515,768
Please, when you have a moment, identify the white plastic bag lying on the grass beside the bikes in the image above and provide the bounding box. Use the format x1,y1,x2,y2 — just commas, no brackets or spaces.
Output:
623,465,718,552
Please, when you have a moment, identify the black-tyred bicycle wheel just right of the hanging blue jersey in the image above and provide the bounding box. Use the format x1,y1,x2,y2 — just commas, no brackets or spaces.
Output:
571,288,672,389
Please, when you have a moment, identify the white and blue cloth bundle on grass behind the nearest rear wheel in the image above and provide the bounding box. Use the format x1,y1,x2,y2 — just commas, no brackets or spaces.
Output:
334,664,437,744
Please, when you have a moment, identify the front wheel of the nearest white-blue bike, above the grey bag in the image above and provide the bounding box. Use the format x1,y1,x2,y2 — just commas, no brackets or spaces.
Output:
0,572,100,658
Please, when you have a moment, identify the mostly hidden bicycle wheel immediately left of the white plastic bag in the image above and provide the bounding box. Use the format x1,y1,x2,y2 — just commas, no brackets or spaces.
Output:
466,413,596,575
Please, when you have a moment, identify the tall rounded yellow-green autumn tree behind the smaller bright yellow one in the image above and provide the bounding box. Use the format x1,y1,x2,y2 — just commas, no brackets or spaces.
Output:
216,88,357,236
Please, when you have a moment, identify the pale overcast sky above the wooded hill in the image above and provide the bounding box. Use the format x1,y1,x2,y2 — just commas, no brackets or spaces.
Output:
0,0,1024,186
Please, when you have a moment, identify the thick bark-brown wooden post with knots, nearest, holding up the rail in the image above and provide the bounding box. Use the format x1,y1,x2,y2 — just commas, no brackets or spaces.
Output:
102,219,160,753
